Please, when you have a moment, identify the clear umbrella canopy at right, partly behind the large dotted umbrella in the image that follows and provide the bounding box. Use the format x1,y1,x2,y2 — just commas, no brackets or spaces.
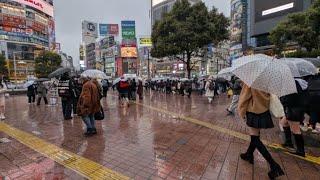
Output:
279,58,317,77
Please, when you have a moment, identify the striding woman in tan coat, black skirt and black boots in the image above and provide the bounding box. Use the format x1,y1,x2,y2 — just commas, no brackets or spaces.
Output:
238,84,284,179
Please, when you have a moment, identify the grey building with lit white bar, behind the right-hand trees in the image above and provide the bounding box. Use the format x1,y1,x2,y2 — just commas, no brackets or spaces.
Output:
230,0,313,57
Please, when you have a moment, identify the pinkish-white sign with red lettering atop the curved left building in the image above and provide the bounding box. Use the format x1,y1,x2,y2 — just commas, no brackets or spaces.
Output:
12,0,53,17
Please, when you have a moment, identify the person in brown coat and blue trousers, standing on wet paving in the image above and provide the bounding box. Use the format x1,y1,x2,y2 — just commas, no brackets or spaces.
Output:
77,77,101,136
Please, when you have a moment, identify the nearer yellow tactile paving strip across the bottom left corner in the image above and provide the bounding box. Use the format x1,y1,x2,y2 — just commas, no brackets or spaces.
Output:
0,122,129,180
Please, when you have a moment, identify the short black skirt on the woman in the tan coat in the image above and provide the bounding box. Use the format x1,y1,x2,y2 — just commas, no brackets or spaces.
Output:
247,111,274,129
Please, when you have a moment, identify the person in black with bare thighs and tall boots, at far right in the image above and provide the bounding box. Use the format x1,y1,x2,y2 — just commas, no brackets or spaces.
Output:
280,78,308,157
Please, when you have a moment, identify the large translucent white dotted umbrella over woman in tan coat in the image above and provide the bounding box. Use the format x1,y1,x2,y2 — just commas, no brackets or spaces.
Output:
232,55,297,97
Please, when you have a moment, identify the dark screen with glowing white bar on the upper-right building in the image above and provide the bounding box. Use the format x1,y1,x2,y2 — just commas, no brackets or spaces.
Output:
254,0,303,22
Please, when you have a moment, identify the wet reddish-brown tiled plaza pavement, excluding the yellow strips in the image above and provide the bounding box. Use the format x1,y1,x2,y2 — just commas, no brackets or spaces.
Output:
0,93,320,180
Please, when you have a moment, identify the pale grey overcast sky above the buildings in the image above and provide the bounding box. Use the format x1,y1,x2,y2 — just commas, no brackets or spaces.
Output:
54,0,230,66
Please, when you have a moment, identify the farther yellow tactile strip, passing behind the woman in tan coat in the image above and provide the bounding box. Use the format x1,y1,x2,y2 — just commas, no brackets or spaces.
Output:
134,102,320,165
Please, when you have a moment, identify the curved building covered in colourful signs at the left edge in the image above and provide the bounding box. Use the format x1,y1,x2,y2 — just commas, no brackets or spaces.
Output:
0,0,56,80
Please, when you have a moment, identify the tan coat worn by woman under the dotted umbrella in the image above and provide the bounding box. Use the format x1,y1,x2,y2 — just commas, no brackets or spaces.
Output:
238,84,270,118
